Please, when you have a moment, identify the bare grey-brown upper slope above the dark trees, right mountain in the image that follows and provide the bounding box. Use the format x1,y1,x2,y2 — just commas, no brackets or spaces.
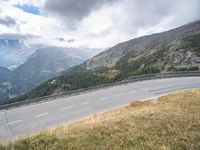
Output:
86,21,200,68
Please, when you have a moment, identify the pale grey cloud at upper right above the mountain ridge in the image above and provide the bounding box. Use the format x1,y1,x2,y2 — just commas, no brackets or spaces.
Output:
105,0,200,35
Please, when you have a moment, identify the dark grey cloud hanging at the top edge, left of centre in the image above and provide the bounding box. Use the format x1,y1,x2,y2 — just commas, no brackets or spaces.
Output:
44,0,117,28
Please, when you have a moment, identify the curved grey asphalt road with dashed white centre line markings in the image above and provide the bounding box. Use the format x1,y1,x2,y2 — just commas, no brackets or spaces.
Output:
0,77,200,141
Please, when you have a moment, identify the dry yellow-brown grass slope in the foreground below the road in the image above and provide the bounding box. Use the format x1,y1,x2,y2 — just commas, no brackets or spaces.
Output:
0,90,200,150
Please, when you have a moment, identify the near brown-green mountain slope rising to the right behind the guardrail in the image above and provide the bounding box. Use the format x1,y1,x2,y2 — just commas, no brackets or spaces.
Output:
4,21,200,102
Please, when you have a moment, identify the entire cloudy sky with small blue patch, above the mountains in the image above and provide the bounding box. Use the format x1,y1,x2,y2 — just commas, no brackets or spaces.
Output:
0,0,200,48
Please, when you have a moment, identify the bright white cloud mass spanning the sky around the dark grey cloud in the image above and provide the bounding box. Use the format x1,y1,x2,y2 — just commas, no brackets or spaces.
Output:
0,0,200,48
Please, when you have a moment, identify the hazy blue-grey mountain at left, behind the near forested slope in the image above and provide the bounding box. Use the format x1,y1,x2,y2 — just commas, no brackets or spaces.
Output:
0,47,90,99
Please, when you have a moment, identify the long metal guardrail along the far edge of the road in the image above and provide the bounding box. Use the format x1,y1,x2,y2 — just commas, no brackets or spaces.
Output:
0,71,200,110
